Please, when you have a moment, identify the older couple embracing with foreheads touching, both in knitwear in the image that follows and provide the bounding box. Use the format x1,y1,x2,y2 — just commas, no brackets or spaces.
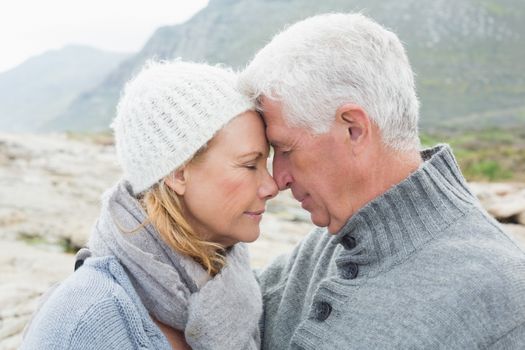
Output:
22,14,525,350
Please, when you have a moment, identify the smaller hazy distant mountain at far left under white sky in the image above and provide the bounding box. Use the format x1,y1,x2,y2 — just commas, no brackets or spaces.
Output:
0,45,125,131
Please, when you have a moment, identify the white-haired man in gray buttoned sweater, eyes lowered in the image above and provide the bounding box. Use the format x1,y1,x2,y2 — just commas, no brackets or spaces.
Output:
240,14,525,350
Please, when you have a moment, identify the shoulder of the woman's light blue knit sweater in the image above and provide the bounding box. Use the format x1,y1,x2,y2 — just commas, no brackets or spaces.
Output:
23,257,162,349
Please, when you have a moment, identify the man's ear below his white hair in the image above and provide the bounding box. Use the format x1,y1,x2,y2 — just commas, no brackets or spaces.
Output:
336,103,372,150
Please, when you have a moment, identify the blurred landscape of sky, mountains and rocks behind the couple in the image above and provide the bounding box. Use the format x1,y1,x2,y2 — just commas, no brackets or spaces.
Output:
0,0,525,349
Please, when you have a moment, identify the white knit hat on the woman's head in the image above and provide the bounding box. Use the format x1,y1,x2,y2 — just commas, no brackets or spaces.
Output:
111,61,254,194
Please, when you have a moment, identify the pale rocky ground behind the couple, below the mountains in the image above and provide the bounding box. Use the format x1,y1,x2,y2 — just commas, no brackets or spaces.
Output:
0,134,525,350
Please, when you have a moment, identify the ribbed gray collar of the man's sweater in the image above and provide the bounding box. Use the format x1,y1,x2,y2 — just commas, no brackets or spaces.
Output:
332,145,477,277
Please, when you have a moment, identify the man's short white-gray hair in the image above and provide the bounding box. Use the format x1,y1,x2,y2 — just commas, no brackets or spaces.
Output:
239,14,420,151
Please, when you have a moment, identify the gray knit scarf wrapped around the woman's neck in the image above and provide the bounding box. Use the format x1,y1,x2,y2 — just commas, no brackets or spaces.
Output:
88,181,262,350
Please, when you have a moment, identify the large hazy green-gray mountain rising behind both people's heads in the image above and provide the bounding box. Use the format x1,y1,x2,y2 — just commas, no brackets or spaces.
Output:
55,0,525,130
